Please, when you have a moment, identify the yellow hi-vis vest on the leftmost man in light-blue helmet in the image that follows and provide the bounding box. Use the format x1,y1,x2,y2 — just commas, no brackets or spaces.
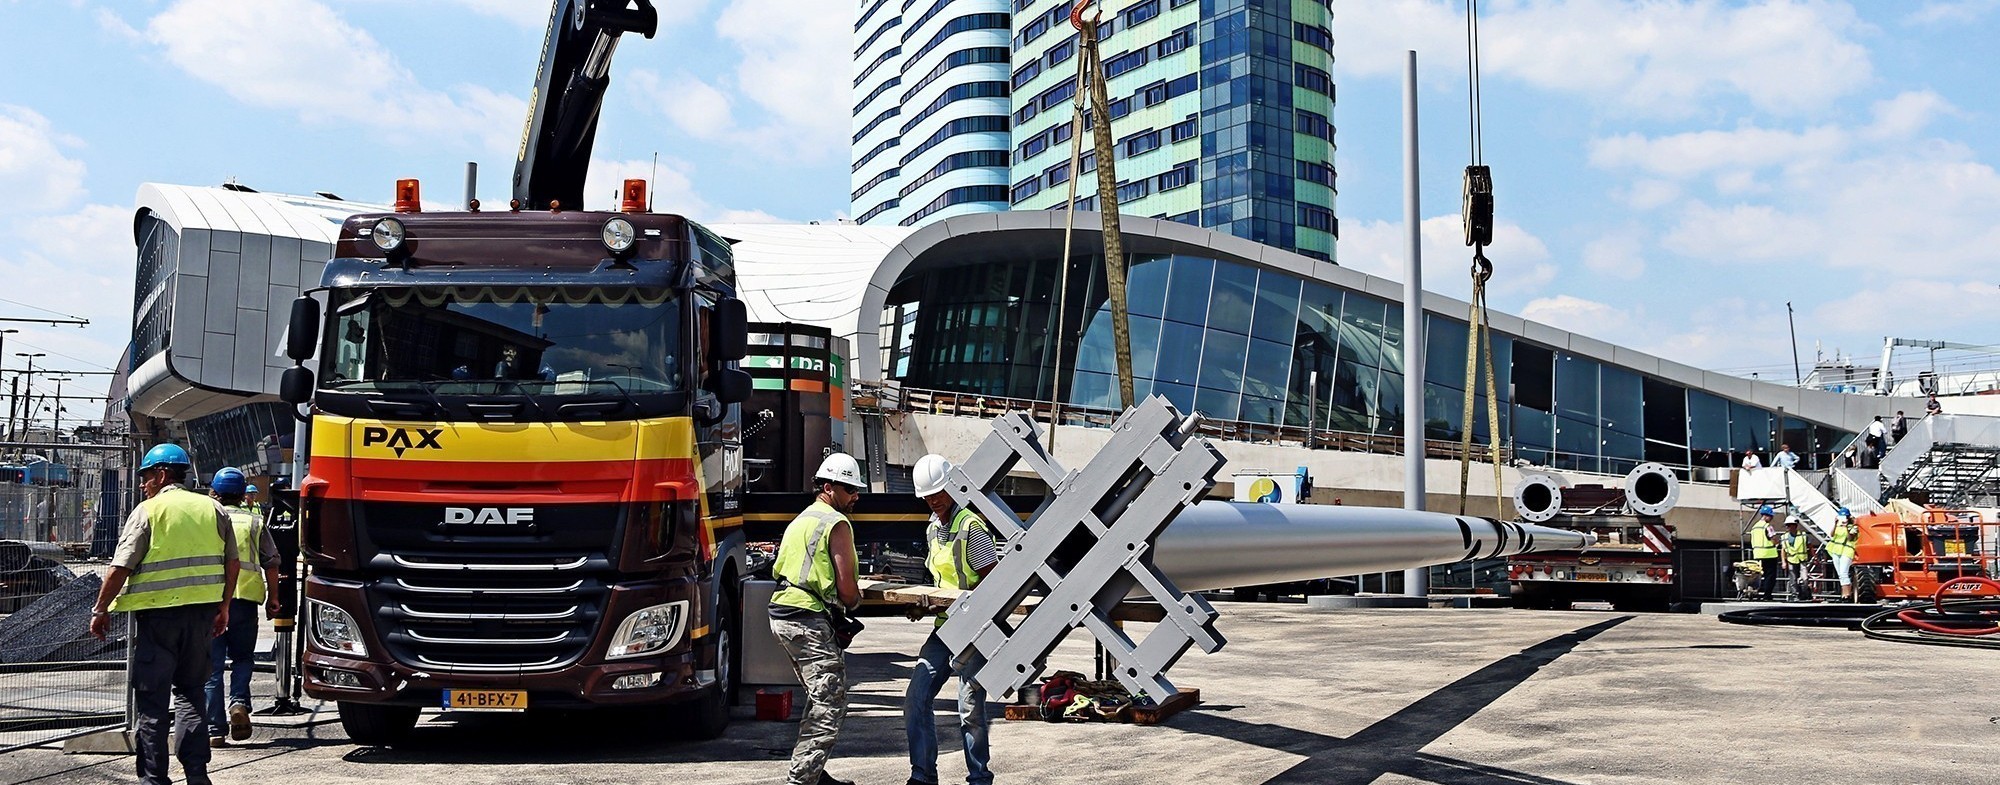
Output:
112,487,224,611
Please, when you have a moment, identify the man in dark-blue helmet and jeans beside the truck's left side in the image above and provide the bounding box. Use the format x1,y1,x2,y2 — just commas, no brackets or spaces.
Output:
208,467,278,747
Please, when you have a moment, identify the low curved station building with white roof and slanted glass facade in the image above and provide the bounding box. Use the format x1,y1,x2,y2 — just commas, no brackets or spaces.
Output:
113,186,1922,539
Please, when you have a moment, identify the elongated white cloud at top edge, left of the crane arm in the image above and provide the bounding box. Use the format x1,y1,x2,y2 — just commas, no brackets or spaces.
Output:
146,0,526,152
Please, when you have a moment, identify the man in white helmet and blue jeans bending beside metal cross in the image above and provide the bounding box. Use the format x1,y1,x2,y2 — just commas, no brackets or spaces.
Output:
902,455,1000,785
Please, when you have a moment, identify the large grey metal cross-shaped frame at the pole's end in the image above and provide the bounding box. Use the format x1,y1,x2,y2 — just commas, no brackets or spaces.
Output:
938,397,1226,701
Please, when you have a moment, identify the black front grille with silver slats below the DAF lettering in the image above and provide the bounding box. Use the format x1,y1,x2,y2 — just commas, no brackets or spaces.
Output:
356,503,618,673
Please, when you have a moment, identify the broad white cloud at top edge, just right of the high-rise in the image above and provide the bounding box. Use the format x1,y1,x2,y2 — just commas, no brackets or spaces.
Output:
1334,0,1872,116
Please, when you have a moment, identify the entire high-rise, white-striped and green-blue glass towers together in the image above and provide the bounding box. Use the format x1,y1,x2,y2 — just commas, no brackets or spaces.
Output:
854,0,1340,258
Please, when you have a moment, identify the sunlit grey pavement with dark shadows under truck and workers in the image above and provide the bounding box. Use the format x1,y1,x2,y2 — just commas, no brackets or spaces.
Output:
0,603,2000,785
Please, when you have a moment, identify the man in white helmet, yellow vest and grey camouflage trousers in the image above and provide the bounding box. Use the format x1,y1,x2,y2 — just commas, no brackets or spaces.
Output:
770,453,866,785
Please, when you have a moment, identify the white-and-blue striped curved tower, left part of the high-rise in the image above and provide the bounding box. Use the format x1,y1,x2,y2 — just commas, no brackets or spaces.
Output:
852,0,1012,226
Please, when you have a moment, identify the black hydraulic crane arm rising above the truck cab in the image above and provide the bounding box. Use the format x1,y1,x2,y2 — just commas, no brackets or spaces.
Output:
514,0,660,210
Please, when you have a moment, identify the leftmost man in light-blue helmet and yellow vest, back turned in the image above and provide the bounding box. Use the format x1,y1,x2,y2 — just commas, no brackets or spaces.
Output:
90,445,236,785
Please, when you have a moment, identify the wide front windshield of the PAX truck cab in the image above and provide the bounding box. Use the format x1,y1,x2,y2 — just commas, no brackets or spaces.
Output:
322,286,684,397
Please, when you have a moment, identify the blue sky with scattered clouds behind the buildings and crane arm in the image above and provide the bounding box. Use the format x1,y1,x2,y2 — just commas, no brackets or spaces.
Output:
0,0,2000,422
